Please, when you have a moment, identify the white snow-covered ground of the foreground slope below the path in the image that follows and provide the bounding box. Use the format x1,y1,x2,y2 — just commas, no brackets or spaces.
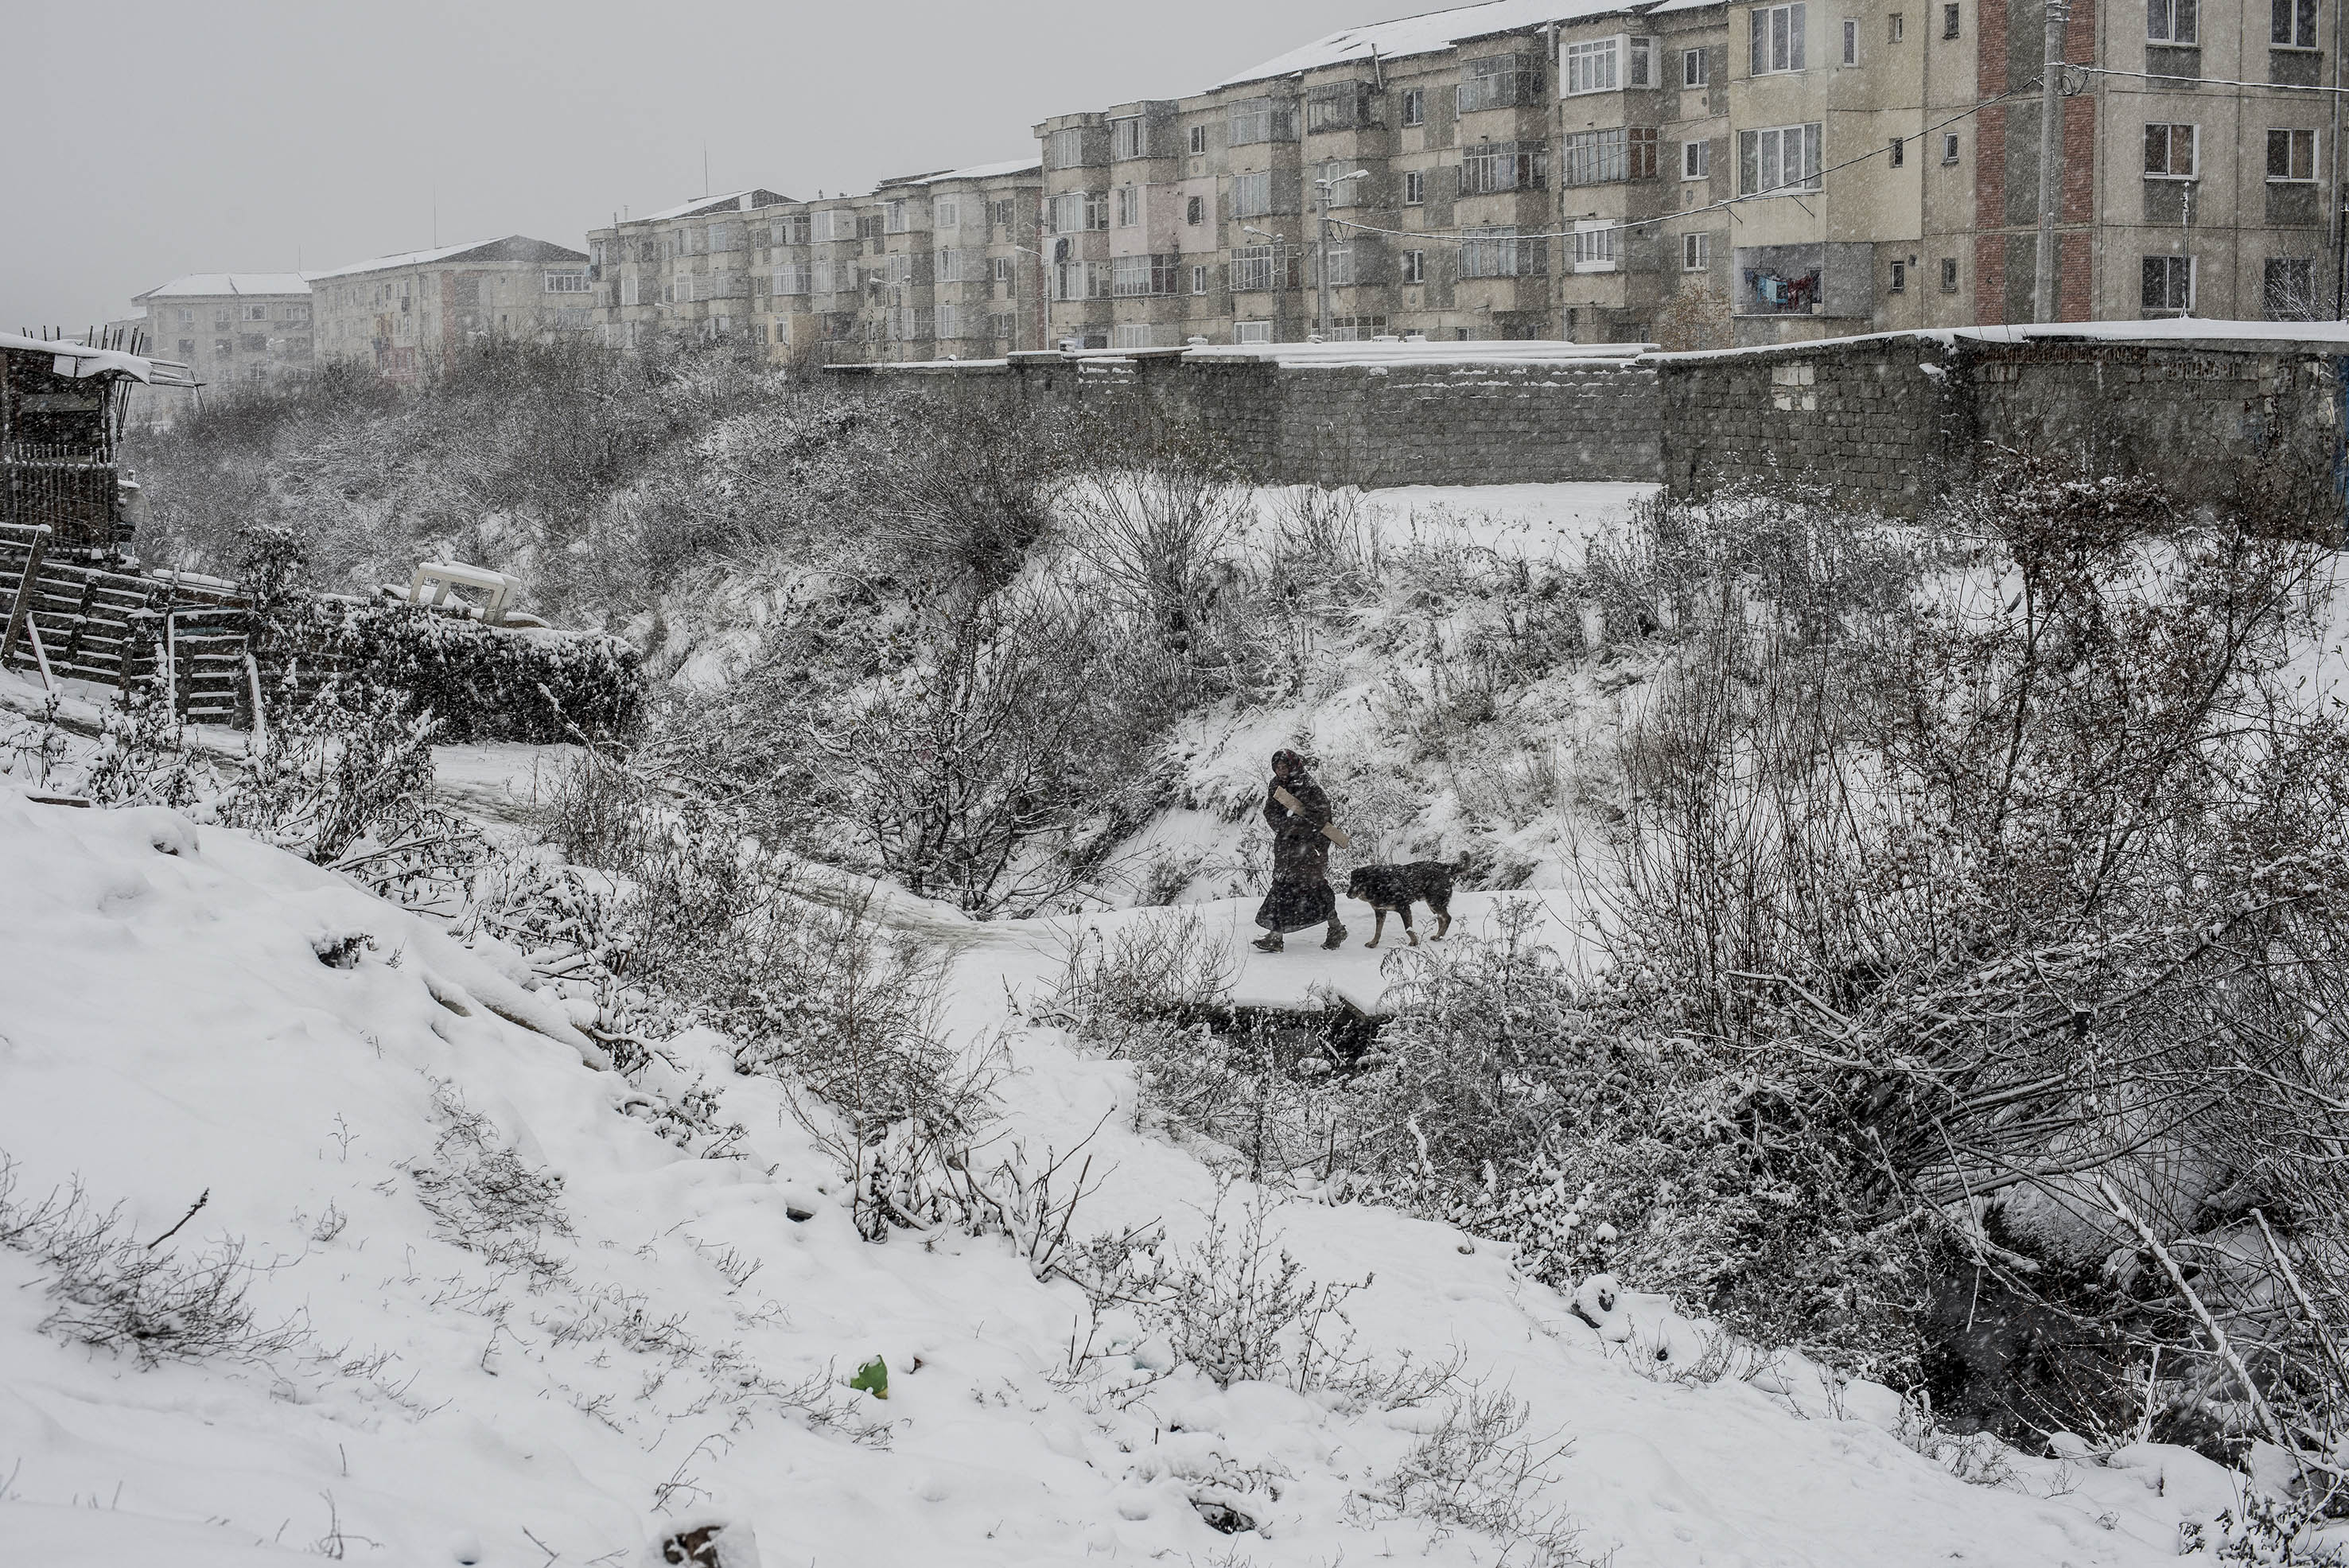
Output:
0,784,2229,1568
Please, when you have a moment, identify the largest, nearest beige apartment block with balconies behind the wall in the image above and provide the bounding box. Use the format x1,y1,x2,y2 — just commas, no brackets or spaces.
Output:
1036,0,2342,348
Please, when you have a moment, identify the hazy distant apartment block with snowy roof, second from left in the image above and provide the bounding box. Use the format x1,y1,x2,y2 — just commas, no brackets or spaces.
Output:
305,235,594,381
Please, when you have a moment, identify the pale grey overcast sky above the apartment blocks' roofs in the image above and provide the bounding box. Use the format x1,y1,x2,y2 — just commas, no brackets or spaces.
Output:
14,0,1371,332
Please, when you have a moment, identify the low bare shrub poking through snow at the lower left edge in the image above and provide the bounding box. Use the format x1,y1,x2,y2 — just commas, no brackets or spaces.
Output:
0,1154,308,1366
